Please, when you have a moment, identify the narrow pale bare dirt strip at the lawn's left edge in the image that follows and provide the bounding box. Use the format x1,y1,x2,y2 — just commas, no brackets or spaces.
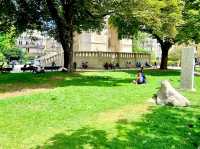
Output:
0,88,49,100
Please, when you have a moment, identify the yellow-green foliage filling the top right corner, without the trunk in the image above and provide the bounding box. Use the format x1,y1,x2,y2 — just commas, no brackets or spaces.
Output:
110,0,200,43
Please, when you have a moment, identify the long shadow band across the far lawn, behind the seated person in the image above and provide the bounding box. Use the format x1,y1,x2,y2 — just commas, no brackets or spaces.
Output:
0,70,179,93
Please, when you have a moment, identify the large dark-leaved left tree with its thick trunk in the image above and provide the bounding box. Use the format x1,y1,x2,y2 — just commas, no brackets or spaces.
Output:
0,0,116,71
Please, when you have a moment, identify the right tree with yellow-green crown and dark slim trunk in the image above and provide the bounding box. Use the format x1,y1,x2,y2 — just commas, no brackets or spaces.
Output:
110,0,183,69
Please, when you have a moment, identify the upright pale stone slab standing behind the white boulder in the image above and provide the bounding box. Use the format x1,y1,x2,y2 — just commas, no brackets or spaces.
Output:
181,47,195,90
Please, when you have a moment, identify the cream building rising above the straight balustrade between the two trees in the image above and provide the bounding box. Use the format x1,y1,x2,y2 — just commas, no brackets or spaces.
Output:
74,25,132,53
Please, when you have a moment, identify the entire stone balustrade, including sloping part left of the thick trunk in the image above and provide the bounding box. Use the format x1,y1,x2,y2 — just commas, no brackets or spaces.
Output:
41,51,151,69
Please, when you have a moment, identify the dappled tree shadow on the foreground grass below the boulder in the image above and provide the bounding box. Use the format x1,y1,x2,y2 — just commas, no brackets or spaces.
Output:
36,107,200,149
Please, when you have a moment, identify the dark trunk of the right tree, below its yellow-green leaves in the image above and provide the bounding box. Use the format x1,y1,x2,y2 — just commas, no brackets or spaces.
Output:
160,43,172,70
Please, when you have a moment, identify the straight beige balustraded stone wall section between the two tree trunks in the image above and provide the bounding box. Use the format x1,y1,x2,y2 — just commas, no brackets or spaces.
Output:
74,52,150,69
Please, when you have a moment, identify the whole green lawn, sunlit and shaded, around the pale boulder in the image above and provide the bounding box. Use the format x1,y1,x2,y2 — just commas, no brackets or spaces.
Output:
0,70,200,149
